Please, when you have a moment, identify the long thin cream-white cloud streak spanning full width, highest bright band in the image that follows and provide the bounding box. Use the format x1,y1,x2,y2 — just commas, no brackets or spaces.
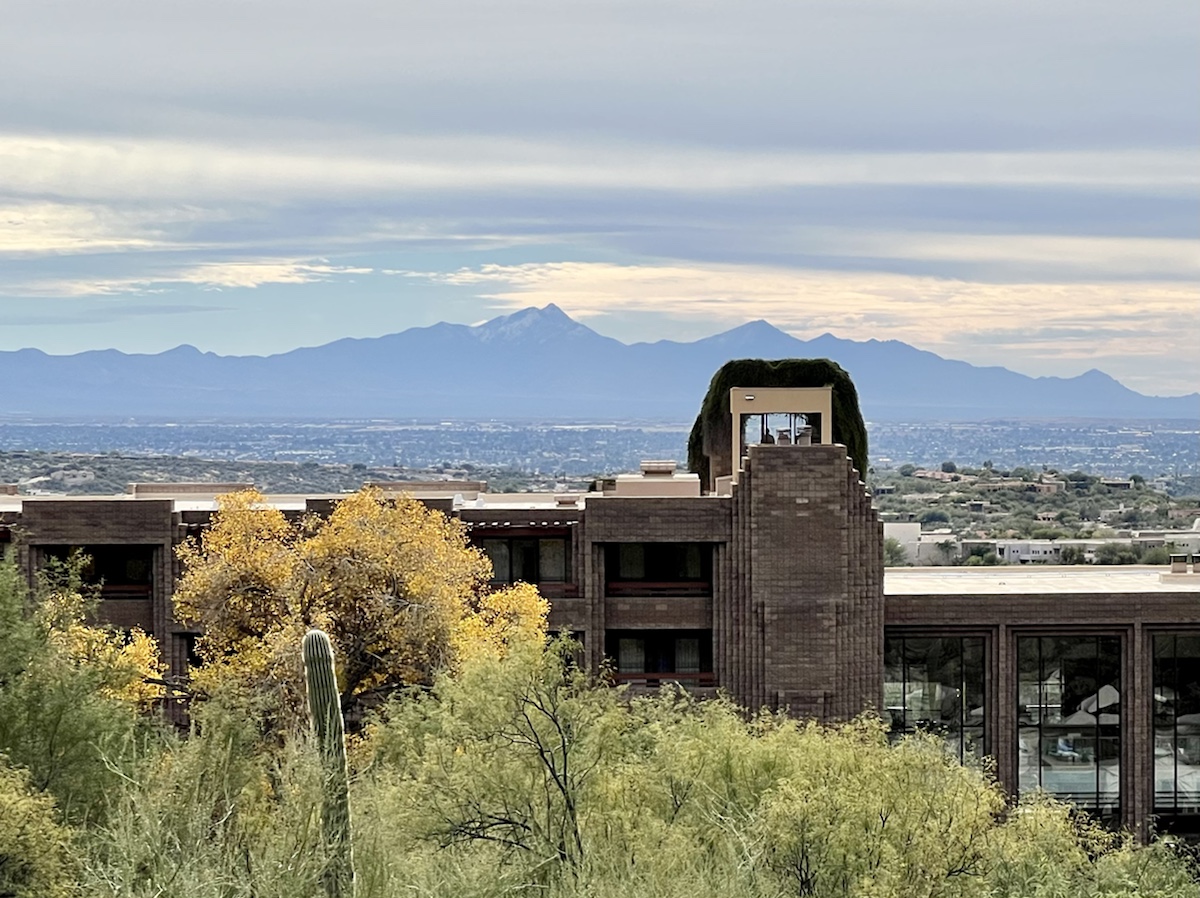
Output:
0,133,1200,202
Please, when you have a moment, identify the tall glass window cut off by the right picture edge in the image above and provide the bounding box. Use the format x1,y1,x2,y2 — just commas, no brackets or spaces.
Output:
1154,634,1200,831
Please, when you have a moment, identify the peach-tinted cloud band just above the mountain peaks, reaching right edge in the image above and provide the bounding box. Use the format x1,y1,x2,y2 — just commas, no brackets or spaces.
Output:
429,255,1200,391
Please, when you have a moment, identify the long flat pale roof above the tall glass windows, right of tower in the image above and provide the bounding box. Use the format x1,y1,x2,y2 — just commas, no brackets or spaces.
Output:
883,564,1200,595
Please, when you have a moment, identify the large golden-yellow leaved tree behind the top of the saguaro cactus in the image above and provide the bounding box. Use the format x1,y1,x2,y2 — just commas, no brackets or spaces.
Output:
175,489,548,720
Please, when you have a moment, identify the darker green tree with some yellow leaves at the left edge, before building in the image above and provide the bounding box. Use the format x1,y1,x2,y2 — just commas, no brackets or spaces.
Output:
0,555,162,820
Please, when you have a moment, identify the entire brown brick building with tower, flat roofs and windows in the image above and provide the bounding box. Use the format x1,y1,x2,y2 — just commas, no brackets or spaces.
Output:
0,390,1200,833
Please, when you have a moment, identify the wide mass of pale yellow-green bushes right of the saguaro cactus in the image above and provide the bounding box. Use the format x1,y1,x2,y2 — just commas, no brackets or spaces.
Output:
358,646,1195,898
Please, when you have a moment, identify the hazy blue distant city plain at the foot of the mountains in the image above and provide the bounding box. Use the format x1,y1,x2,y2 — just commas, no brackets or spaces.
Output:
0,420,1200,492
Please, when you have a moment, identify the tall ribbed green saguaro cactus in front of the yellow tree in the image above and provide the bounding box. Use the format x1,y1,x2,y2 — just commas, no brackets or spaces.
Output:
304,630,354,898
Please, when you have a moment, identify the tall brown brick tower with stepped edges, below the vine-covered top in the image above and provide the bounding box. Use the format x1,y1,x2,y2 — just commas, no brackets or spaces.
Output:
732,445,883,720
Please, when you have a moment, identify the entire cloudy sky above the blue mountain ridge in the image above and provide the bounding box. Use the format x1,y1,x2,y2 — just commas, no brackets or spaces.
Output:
0,0,1200,395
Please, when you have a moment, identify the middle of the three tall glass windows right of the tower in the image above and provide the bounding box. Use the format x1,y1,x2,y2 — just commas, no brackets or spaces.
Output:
1016,636,1121,818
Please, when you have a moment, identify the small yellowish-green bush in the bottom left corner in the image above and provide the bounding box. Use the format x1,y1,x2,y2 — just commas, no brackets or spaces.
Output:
0,755,76,898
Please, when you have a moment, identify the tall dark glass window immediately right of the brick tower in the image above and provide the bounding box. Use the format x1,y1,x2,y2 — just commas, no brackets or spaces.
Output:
883,635,986,760
